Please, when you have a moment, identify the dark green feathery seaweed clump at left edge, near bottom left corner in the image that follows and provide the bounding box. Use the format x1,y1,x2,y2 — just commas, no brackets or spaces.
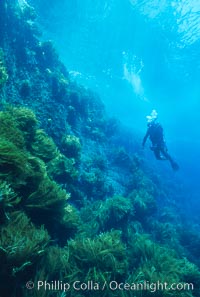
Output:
0,212,50,274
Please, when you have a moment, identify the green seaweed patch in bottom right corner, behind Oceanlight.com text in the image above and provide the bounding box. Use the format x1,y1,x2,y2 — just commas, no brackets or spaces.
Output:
128,234,200,297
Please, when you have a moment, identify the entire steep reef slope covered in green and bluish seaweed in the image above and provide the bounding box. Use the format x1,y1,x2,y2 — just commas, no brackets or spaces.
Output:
0,0,200,297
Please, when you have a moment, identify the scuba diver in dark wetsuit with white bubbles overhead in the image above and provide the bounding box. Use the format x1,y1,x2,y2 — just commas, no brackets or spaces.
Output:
142,109,179,170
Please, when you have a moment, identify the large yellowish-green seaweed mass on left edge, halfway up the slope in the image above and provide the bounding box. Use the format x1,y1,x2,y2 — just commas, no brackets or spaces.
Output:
0,107,78,241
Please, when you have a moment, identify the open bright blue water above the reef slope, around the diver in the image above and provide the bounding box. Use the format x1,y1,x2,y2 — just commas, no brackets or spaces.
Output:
32,0,200,217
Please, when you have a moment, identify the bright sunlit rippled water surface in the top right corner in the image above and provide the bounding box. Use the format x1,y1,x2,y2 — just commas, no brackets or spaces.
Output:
129,0,200,48
